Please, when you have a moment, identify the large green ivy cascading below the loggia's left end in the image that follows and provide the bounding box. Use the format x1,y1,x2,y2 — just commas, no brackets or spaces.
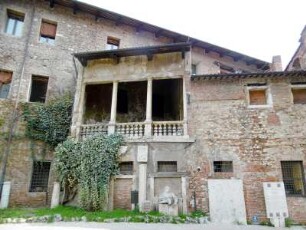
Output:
54,134,123,211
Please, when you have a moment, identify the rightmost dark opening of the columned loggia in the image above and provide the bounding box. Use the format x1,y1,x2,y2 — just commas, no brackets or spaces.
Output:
152,79,183,121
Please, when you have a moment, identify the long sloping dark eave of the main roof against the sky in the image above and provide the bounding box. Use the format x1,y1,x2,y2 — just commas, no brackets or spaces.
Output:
45,0,270,71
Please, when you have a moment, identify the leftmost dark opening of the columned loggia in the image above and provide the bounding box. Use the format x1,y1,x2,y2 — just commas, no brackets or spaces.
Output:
83,83,113,124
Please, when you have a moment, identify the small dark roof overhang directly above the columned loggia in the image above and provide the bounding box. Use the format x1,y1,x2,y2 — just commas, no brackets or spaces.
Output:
73,43,190,66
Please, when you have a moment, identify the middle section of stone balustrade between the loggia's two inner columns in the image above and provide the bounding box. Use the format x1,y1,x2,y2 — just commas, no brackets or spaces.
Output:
116,122,145,138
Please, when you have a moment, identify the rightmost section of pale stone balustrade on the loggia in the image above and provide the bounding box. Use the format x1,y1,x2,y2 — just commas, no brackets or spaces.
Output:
152,121,184,137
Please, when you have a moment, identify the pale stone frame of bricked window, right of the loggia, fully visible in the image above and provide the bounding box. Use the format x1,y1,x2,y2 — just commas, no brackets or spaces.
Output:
246,85,273,109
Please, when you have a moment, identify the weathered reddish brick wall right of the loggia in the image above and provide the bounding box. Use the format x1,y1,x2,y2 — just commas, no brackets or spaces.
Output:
186,78,306,222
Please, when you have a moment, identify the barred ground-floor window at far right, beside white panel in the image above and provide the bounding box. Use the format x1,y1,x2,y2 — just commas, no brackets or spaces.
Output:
281,161,305,196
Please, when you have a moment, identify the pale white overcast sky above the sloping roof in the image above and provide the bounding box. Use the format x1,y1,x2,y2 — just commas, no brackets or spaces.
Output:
81,0,306,68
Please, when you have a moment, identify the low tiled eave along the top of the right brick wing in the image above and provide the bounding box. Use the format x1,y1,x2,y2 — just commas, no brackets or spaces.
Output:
191,70,306,81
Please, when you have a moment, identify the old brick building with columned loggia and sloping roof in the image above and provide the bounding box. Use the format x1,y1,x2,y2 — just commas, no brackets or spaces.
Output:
0,0,306,222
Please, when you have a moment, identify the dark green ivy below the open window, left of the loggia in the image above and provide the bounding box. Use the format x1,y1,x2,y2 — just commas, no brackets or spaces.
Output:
23,95,72,148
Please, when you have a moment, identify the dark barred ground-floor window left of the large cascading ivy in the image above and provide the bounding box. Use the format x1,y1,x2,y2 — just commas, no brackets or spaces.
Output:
30,161,51,192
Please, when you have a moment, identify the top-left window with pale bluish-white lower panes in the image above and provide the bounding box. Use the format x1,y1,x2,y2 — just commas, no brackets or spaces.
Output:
5,10,24,36
